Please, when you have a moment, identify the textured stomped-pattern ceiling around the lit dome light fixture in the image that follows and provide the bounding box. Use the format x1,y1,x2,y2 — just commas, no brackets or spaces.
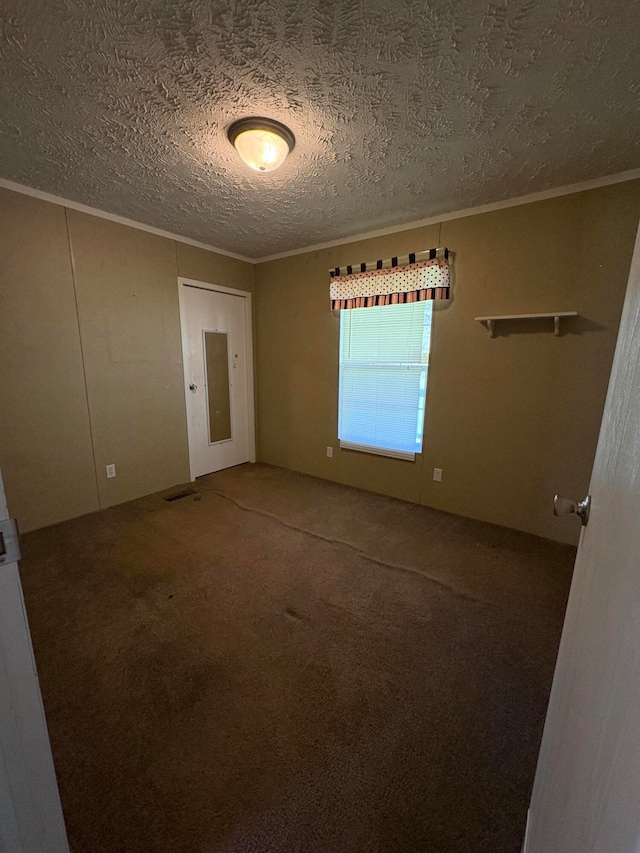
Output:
0,0,640,258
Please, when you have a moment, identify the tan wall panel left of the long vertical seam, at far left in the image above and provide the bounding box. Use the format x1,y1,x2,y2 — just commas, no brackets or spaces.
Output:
0,190,98,530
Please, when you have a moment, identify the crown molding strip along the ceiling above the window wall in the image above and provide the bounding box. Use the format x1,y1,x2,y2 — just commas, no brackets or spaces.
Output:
253,169,640,264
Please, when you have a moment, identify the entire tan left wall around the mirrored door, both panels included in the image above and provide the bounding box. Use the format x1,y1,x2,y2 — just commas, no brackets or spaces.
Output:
0,190,254,530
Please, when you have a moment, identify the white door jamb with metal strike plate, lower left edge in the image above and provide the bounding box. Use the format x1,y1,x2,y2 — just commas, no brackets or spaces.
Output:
0,472,69,853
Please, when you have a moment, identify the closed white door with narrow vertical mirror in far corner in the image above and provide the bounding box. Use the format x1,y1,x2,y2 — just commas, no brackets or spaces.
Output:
180,281,255,479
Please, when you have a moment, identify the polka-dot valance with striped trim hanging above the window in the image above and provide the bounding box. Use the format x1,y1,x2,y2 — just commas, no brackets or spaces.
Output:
329,249,449,310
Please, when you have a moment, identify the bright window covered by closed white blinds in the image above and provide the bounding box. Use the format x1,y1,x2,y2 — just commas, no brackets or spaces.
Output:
338,301,433,459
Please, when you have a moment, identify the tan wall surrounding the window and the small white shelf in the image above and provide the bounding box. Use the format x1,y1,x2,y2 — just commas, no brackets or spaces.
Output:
256,181,640,542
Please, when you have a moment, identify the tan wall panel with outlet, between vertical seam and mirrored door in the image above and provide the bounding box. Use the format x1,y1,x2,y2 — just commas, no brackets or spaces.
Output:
68,210,189,506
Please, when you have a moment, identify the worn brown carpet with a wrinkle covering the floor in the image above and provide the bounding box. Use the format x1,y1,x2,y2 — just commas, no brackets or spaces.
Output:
21,465,574,853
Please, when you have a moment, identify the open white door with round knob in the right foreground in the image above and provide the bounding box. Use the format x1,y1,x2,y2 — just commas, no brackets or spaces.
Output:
525,223,640,853
